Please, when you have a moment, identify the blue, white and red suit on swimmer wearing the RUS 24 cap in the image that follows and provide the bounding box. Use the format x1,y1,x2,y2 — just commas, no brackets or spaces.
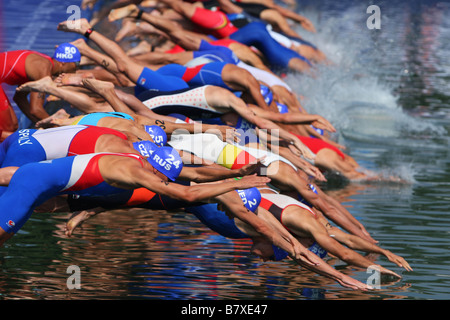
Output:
0,153,146,233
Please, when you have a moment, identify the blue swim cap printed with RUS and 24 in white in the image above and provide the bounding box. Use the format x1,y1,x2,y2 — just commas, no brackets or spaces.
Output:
147,147,183,181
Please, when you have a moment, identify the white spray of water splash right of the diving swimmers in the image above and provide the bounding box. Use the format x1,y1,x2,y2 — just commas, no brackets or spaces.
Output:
286,5,448,142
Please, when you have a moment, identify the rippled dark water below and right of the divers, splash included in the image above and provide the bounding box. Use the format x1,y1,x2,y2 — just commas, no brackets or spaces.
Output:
0,0,450,300
